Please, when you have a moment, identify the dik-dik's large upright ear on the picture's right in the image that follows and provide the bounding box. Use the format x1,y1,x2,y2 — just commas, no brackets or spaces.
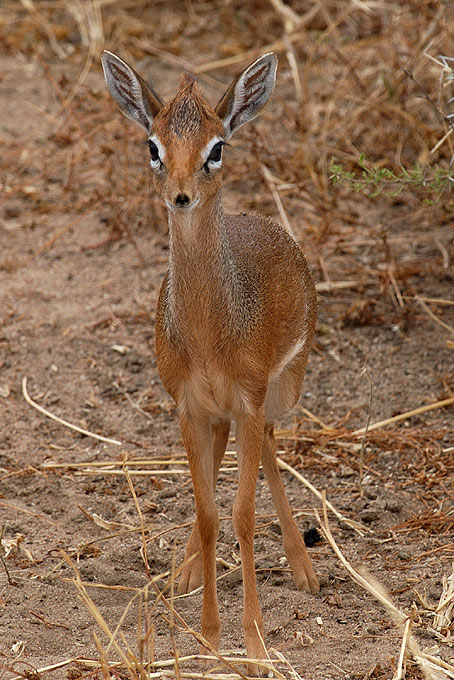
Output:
215,52,277,139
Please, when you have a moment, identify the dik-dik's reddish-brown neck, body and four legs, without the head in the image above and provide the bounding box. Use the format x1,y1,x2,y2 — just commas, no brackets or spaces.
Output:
156,190,318,673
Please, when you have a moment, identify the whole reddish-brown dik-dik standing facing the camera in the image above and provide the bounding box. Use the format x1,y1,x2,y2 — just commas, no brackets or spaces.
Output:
102,52,319,674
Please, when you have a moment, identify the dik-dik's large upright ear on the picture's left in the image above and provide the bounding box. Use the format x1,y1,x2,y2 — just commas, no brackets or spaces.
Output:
101,50,164,133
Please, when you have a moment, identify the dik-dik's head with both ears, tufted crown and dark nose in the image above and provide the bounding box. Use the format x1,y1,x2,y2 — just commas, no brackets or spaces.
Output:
102,51,277,211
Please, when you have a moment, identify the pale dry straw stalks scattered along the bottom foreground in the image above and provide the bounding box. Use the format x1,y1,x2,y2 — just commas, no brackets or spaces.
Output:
5,456,454,680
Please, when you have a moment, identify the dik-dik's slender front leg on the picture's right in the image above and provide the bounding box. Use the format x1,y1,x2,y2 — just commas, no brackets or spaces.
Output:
233,413,266,675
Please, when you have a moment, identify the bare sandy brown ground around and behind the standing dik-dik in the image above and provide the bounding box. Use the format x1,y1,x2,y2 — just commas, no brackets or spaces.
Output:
0,17,454,680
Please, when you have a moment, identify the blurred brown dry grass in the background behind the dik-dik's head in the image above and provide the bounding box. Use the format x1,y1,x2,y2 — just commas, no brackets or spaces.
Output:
0,0,454,362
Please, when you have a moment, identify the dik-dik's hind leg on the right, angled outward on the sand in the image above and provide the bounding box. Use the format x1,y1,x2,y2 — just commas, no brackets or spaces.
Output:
262,423,320,593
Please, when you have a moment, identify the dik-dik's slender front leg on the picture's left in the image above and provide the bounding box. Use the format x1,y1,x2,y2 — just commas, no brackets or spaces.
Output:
180,413,221,653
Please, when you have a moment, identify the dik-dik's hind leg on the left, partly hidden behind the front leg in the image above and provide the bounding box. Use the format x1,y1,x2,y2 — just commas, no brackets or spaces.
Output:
178,420,230,593
